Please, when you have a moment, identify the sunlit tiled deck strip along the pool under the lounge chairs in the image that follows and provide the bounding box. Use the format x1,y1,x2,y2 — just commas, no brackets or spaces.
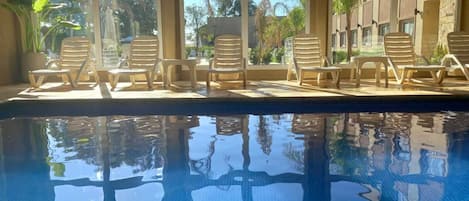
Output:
0,78,469,102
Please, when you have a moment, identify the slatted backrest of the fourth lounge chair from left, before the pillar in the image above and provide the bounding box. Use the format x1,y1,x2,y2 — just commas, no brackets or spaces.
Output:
293,34,322,68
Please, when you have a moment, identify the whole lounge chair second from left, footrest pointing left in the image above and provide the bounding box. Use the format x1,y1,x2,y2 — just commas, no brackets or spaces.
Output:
108,36,160,89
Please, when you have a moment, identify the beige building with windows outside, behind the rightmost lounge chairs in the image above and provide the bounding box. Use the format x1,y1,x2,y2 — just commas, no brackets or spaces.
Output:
331,0,464,57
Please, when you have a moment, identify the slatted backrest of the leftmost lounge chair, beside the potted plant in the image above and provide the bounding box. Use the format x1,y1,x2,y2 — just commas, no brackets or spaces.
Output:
59,37,91,69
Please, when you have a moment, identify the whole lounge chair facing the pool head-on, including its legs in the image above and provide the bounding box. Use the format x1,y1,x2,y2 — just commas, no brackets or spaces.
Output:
207,34,247,88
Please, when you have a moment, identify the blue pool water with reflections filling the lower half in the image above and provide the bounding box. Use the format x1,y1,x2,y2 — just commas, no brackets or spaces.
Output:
0,111,469,201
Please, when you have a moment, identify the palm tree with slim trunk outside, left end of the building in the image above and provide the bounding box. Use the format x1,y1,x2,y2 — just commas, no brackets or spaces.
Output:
333,0,359,61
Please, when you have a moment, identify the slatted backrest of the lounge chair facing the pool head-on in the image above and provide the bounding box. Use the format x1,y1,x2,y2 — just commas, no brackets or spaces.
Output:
213,34,243,68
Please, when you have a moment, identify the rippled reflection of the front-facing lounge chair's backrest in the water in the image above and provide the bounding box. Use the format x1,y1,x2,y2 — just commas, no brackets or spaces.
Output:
215,115,249,135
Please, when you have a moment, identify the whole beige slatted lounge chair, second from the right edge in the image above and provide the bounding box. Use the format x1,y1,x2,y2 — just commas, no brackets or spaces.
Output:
384,32,445,84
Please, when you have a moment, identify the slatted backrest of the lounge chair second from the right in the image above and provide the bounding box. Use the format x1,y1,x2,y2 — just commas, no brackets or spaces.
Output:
384,32,416,66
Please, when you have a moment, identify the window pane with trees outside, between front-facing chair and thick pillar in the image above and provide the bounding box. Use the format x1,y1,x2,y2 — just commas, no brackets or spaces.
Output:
248,0,306,65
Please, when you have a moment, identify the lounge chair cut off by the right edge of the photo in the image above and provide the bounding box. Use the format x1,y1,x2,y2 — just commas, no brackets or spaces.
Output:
442,32,469,80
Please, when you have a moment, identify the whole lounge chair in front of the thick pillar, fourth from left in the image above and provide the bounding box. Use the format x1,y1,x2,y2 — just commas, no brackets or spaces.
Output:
293,34,341,87
